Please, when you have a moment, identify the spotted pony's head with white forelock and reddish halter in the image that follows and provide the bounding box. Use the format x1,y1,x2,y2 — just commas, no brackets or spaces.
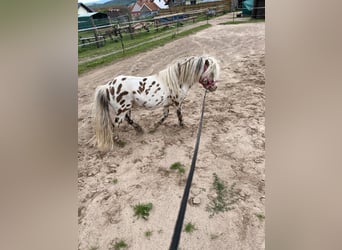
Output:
199,57,220,91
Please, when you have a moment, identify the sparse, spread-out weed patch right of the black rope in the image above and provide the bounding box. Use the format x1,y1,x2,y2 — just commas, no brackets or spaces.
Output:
207,173,241,217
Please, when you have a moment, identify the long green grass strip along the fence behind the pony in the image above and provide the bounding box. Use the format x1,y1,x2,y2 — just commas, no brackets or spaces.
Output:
78,24,211,74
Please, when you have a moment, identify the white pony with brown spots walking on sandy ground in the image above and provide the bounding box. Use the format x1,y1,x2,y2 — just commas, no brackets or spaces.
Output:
94,56,220,150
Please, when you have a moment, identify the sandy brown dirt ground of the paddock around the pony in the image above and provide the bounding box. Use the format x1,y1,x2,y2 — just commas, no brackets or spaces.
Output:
78,16,265,250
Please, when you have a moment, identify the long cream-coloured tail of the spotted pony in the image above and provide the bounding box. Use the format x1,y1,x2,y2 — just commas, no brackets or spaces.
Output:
94,85,114,151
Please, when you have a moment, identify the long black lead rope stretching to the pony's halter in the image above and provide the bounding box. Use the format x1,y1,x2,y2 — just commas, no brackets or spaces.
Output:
170,90,208,250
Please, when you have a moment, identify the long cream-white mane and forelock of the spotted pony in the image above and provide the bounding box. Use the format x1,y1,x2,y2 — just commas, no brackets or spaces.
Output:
158,56,219,93
